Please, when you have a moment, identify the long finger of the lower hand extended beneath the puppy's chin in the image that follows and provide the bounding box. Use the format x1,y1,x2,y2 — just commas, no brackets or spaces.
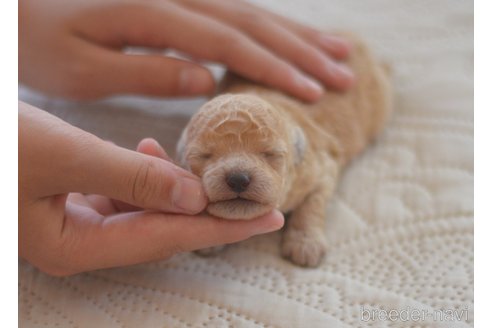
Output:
65,211,284,273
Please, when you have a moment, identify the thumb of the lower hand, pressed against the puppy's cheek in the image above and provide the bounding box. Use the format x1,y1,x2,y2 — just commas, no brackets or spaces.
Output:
74,142,207,214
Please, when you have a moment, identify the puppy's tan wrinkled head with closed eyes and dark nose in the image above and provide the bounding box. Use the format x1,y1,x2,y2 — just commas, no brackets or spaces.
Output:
177,94,305,219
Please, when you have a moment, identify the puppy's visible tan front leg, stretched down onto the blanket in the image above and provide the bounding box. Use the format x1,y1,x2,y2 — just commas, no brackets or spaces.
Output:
282,183,333,267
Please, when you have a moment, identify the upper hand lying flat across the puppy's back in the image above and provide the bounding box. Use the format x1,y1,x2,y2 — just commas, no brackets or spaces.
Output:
19,0,354,101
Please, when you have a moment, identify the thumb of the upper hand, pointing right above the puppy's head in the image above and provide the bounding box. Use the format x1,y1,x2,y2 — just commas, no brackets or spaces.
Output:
90,49,215,96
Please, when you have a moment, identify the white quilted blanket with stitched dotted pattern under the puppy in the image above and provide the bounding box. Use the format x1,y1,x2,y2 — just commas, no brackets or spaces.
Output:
19,0,473,327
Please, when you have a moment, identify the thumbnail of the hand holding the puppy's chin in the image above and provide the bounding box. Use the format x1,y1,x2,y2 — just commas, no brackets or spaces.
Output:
172,177,207,214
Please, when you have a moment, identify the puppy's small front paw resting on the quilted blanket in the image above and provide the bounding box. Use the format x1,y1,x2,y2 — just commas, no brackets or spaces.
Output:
282,229,327,267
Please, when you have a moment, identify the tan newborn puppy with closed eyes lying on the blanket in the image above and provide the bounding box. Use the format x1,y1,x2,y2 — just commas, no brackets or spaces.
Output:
177,37,391,267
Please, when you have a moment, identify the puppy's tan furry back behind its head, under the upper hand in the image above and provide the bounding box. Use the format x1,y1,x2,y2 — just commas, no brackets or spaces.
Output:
222,33,392,164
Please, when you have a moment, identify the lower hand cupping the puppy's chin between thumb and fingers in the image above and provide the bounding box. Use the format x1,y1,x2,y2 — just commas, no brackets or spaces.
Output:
19,103,284,276
